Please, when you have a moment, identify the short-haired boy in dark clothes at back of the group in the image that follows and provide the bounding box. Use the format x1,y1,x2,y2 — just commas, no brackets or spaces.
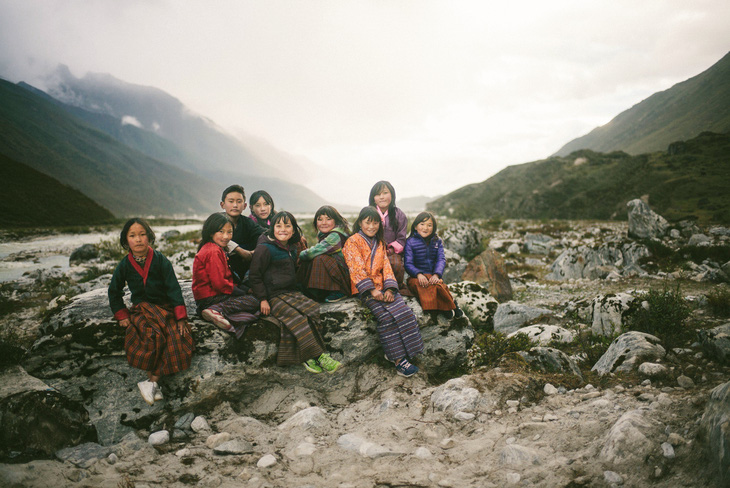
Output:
221,185,266,283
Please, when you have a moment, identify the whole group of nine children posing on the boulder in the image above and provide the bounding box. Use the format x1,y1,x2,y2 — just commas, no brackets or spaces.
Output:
109,181,462,405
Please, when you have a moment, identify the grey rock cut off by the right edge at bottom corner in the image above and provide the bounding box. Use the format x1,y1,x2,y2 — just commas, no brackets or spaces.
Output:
700,382,730,486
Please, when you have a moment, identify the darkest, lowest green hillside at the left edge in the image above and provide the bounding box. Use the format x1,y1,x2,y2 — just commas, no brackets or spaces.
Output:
0,155,114,228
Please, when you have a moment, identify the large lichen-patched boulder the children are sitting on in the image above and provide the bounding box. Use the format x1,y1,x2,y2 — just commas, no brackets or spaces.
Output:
23,280,474,445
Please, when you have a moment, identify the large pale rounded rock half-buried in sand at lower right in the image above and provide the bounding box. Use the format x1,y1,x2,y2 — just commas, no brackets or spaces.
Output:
600,410,662,465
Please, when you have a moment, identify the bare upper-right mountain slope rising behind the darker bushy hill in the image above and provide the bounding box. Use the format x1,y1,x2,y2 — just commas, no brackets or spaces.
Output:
555,53,730,156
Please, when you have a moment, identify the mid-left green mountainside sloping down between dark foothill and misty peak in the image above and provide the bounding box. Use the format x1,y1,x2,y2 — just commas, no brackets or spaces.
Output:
0,80,220,217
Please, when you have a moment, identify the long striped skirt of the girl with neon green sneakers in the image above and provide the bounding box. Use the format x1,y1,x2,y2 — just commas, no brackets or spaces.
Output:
269,291,324,366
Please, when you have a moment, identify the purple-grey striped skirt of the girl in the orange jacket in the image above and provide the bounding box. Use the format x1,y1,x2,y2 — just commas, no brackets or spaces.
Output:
361,293,423,361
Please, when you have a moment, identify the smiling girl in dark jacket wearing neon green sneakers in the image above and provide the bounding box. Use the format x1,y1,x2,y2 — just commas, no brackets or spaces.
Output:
249,212,340,373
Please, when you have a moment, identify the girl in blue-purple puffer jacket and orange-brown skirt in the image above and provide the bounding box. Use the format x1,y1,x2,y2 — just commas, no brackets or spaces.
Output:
403,212,464,319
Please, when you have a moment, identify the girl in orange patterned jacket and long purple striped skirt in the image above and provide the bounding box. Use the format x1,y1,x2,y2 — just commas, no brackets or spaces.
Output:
342,207,423,377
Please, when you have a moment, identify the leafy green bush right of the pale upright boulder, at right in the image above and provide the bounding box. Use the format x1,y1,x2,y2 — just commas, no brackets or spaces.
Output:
625,286,690,349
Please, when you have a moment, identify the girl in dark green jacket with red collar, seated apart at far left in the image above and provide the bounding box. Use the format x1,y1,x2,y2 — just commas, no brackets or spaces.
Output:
109,218,195,405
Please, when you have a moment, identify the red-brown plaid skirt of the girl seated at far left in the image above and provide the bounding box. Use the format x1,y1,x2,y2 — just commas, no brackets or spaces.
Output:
124,302,195,376
